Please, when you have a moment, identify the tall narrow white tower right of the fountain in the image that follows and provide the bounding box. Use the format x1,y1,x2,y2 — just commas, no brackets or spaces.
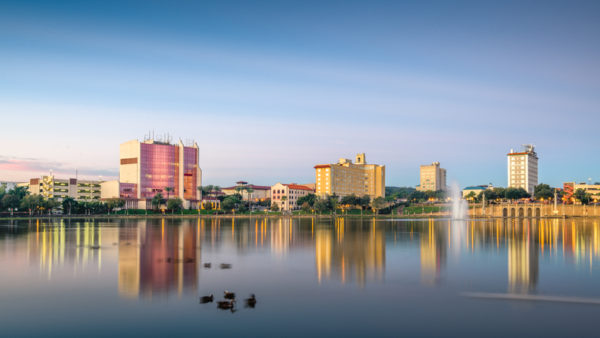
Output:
507,144,538,194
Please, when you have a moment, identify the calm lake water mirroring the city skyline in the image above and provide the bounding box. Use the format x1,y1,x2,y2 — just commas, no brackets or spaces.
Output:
0,219,600,337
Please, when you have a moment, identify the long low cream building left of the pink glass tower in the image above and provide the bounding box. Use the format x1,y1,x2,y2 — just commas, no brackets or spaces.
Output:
28,175,102,201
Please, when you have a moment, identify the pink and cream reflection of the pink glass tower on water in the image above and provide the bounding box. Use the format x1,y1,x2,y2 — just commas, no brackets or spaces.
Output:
119,219,200,298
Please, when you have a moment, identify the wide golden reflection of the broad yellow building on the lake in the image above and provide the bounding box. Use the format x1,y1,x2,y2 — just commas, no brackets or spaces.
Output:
315,218,385,286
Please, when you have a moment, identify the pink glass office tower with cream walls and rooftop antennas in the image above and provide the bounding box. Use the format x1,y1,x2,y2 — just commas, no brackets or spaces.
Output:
119,139,202,208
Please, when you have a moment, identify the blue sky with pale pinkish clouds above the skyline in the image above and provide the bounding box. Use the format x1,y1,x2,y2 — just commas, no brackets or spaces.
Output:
0,0,600,187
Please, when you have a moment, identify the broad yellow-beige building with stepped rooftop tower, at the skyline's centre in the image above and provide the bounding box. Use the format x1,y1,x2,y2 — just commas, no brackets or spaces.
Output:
315,153,385,199
